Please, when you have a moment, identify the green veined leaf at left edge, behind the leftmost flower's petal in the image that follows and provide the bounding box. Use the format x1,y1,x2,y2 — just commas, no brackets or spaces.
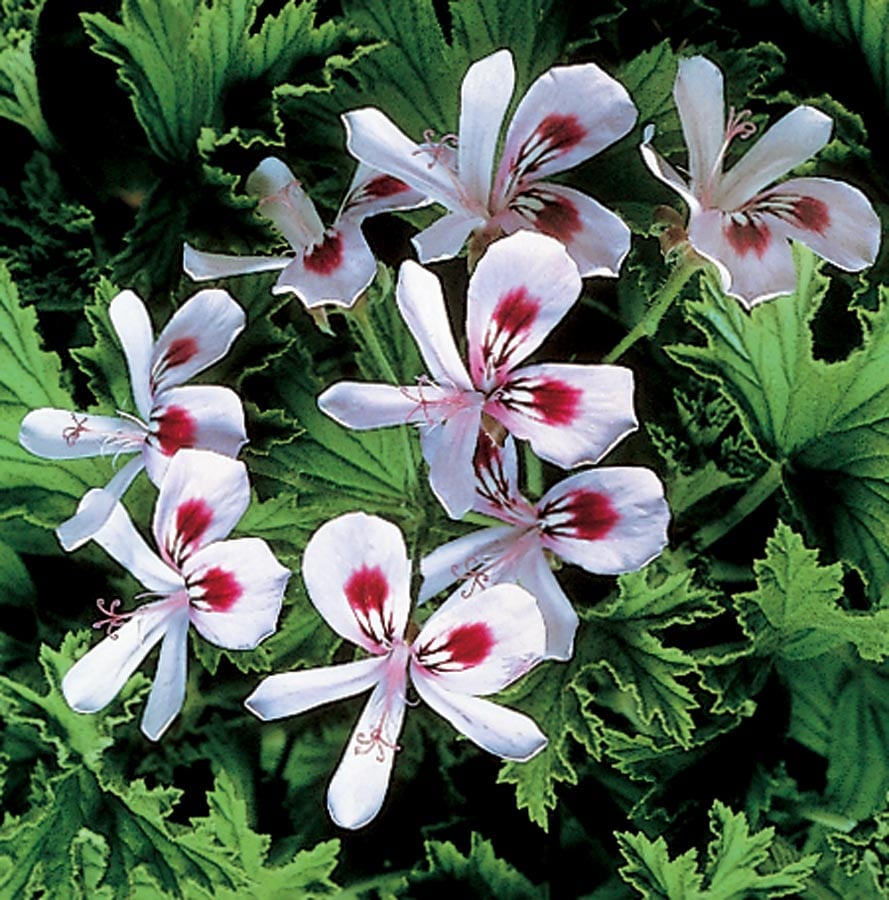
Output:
0,264,107,553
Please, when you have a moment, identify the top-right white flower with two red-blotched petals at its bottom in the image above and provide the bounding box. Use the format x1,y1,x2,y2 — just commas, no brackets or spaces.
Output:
641,56,880,308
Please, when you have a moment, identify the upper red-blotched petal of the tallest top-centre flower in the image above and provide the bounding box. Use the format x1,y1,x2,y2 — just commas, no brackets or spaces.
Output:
492,63,636,208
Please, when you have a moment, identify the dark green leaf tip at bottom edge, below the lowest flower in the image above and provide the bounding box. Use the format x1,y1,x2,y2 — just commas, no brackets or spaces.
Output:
405,832,541,900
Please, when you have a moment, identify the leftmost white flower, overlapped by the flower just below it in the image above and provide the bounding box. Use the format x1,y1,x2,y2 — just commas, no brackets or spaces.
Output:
19,290,247,550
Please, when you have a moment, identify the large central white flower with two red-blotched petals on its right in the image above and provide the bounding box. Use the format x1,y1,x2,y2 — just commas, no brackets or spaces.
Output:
318,231,636,518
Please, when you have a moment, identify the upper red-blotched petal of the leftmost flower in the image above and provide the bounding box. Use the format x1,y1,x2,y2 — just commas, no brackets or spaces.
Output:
151,288,246,397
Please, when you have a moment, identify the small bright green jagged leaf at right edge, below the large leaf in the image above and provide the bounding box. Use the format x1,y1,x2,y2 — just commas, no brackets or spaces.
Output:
734,522,889,662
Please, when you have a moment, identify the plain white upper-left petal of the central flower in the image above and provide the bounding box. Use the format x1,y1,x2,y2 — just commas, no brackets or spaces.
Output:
395,260,473,391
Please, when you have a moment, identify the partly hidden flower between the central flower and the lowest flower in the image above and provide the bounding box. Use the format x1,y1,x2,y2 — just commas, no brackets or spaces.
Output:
420,435,670,659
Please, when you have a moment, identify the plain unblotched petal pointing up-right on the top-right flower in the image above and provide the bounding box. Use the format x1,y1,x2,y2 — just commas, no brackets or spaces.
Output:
713,106,833,210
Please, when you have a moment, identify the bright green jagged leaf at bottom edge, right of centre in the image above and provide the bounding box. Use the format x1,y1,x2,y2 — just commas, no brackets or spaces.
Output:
617,800,818,900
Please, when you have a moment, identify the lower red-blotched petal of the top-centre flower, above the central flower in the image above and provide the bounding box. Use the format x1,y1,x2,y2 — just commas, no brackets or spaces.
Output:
500,182,630,278
